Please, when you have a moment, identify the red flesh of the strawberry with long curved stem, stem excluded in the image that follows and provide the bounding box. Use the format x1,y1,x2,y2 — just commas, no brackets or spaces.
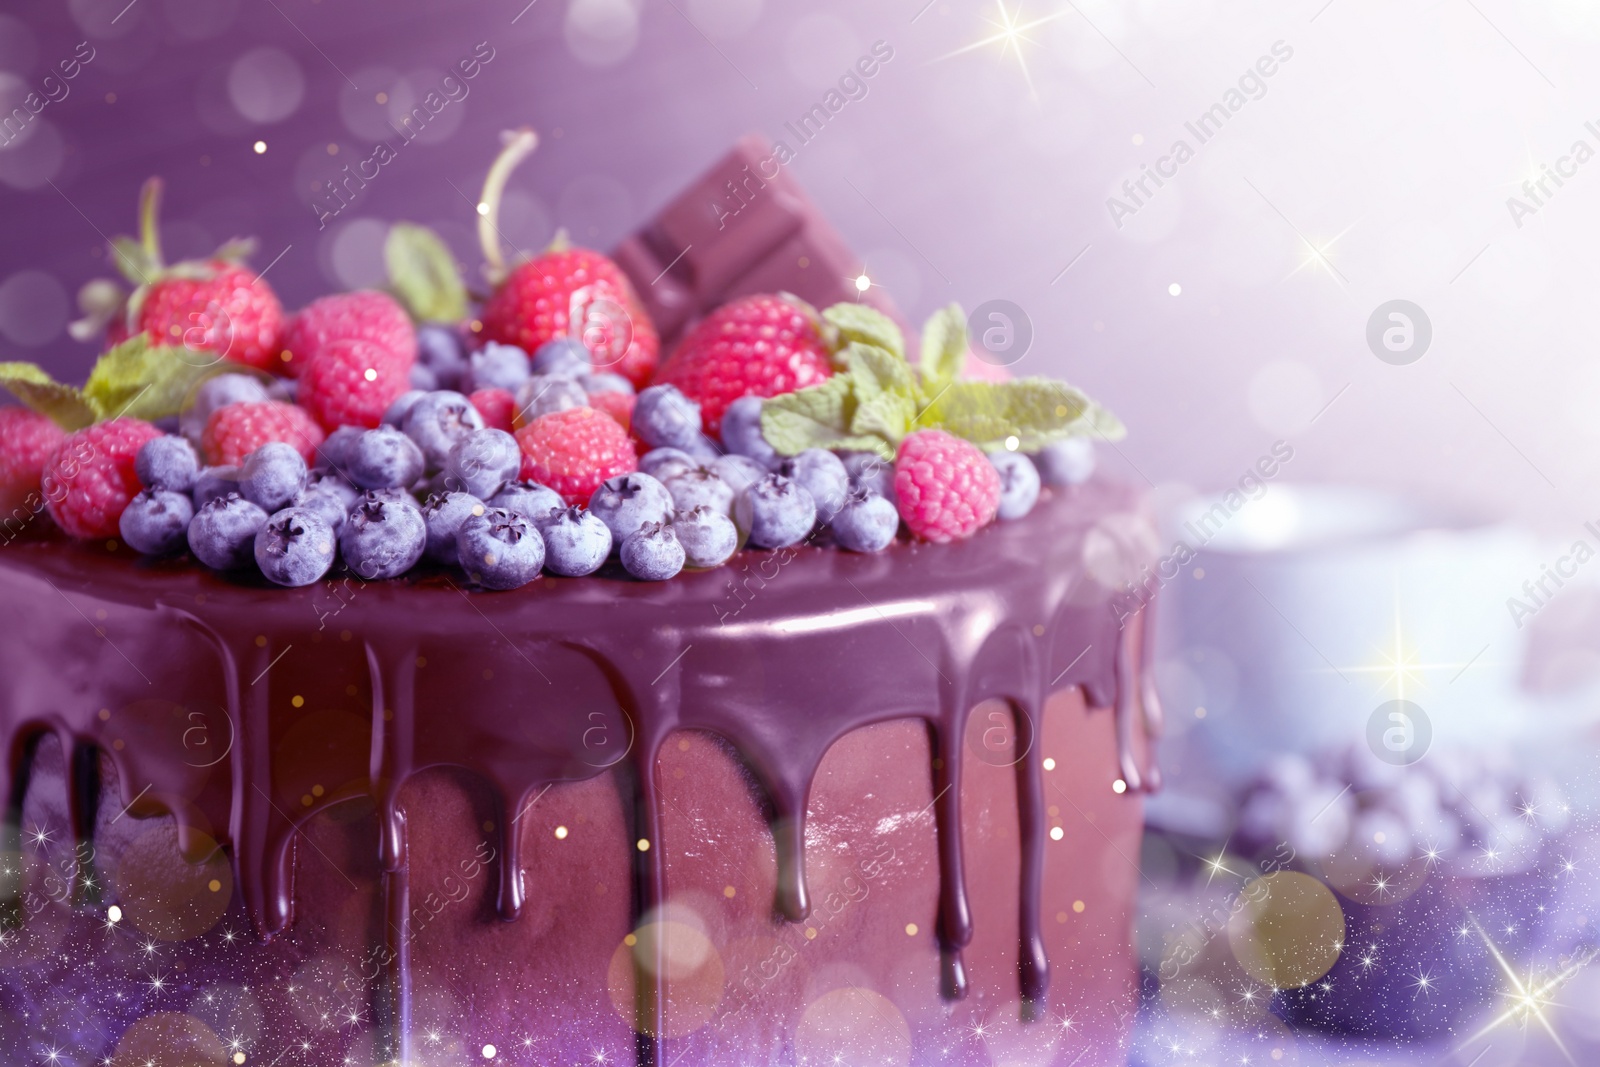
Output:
483,246,661,387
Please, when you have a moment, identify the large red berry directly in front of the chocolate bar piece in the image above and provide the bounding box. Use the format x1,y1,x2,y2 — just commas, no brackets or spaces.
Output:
656,294,834,437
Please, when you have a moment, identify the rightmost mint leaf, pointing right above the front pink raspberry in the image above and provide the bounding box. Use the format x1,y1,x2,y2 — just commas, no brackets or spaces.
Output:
920,378,1123,453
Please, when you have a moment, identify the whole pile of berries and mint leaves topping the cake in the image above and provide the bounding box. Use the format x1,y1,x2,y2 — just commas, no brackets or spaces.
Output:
0,130,1123,590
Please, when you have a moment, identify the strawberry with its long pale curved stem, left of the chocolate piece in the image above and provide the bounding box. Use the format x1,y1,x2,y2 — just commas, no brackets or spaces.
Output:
478,130,661,389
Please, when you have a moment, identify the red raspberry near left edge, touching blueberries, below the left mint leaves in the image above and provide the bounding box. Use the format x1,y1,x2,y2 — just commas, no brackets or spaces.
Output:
40,418,162,541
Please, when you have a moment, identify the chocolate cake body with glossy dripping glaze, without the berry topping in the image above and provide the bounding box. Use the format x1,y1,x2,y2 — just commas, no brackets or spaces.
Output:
0,482,1146,1064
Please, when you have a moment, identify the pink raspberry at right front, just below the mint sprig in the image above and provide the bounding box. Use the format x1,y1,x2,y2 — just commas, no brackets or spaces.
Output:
894,430,1000,544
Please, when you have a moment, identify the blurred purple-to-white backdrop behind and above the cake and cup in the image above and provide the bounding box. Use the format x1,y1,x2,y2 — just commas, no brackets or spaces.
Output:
0,0,1600,527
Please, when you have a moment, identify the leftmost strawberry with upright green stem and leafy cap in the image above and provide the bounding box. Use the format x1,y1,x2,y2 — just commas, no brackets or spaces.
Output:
72,178,283,379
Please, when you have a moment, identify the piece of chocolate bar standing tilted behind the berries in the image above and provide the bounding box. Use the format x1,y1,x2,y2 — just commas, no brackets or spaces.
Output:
613,134,899,346
